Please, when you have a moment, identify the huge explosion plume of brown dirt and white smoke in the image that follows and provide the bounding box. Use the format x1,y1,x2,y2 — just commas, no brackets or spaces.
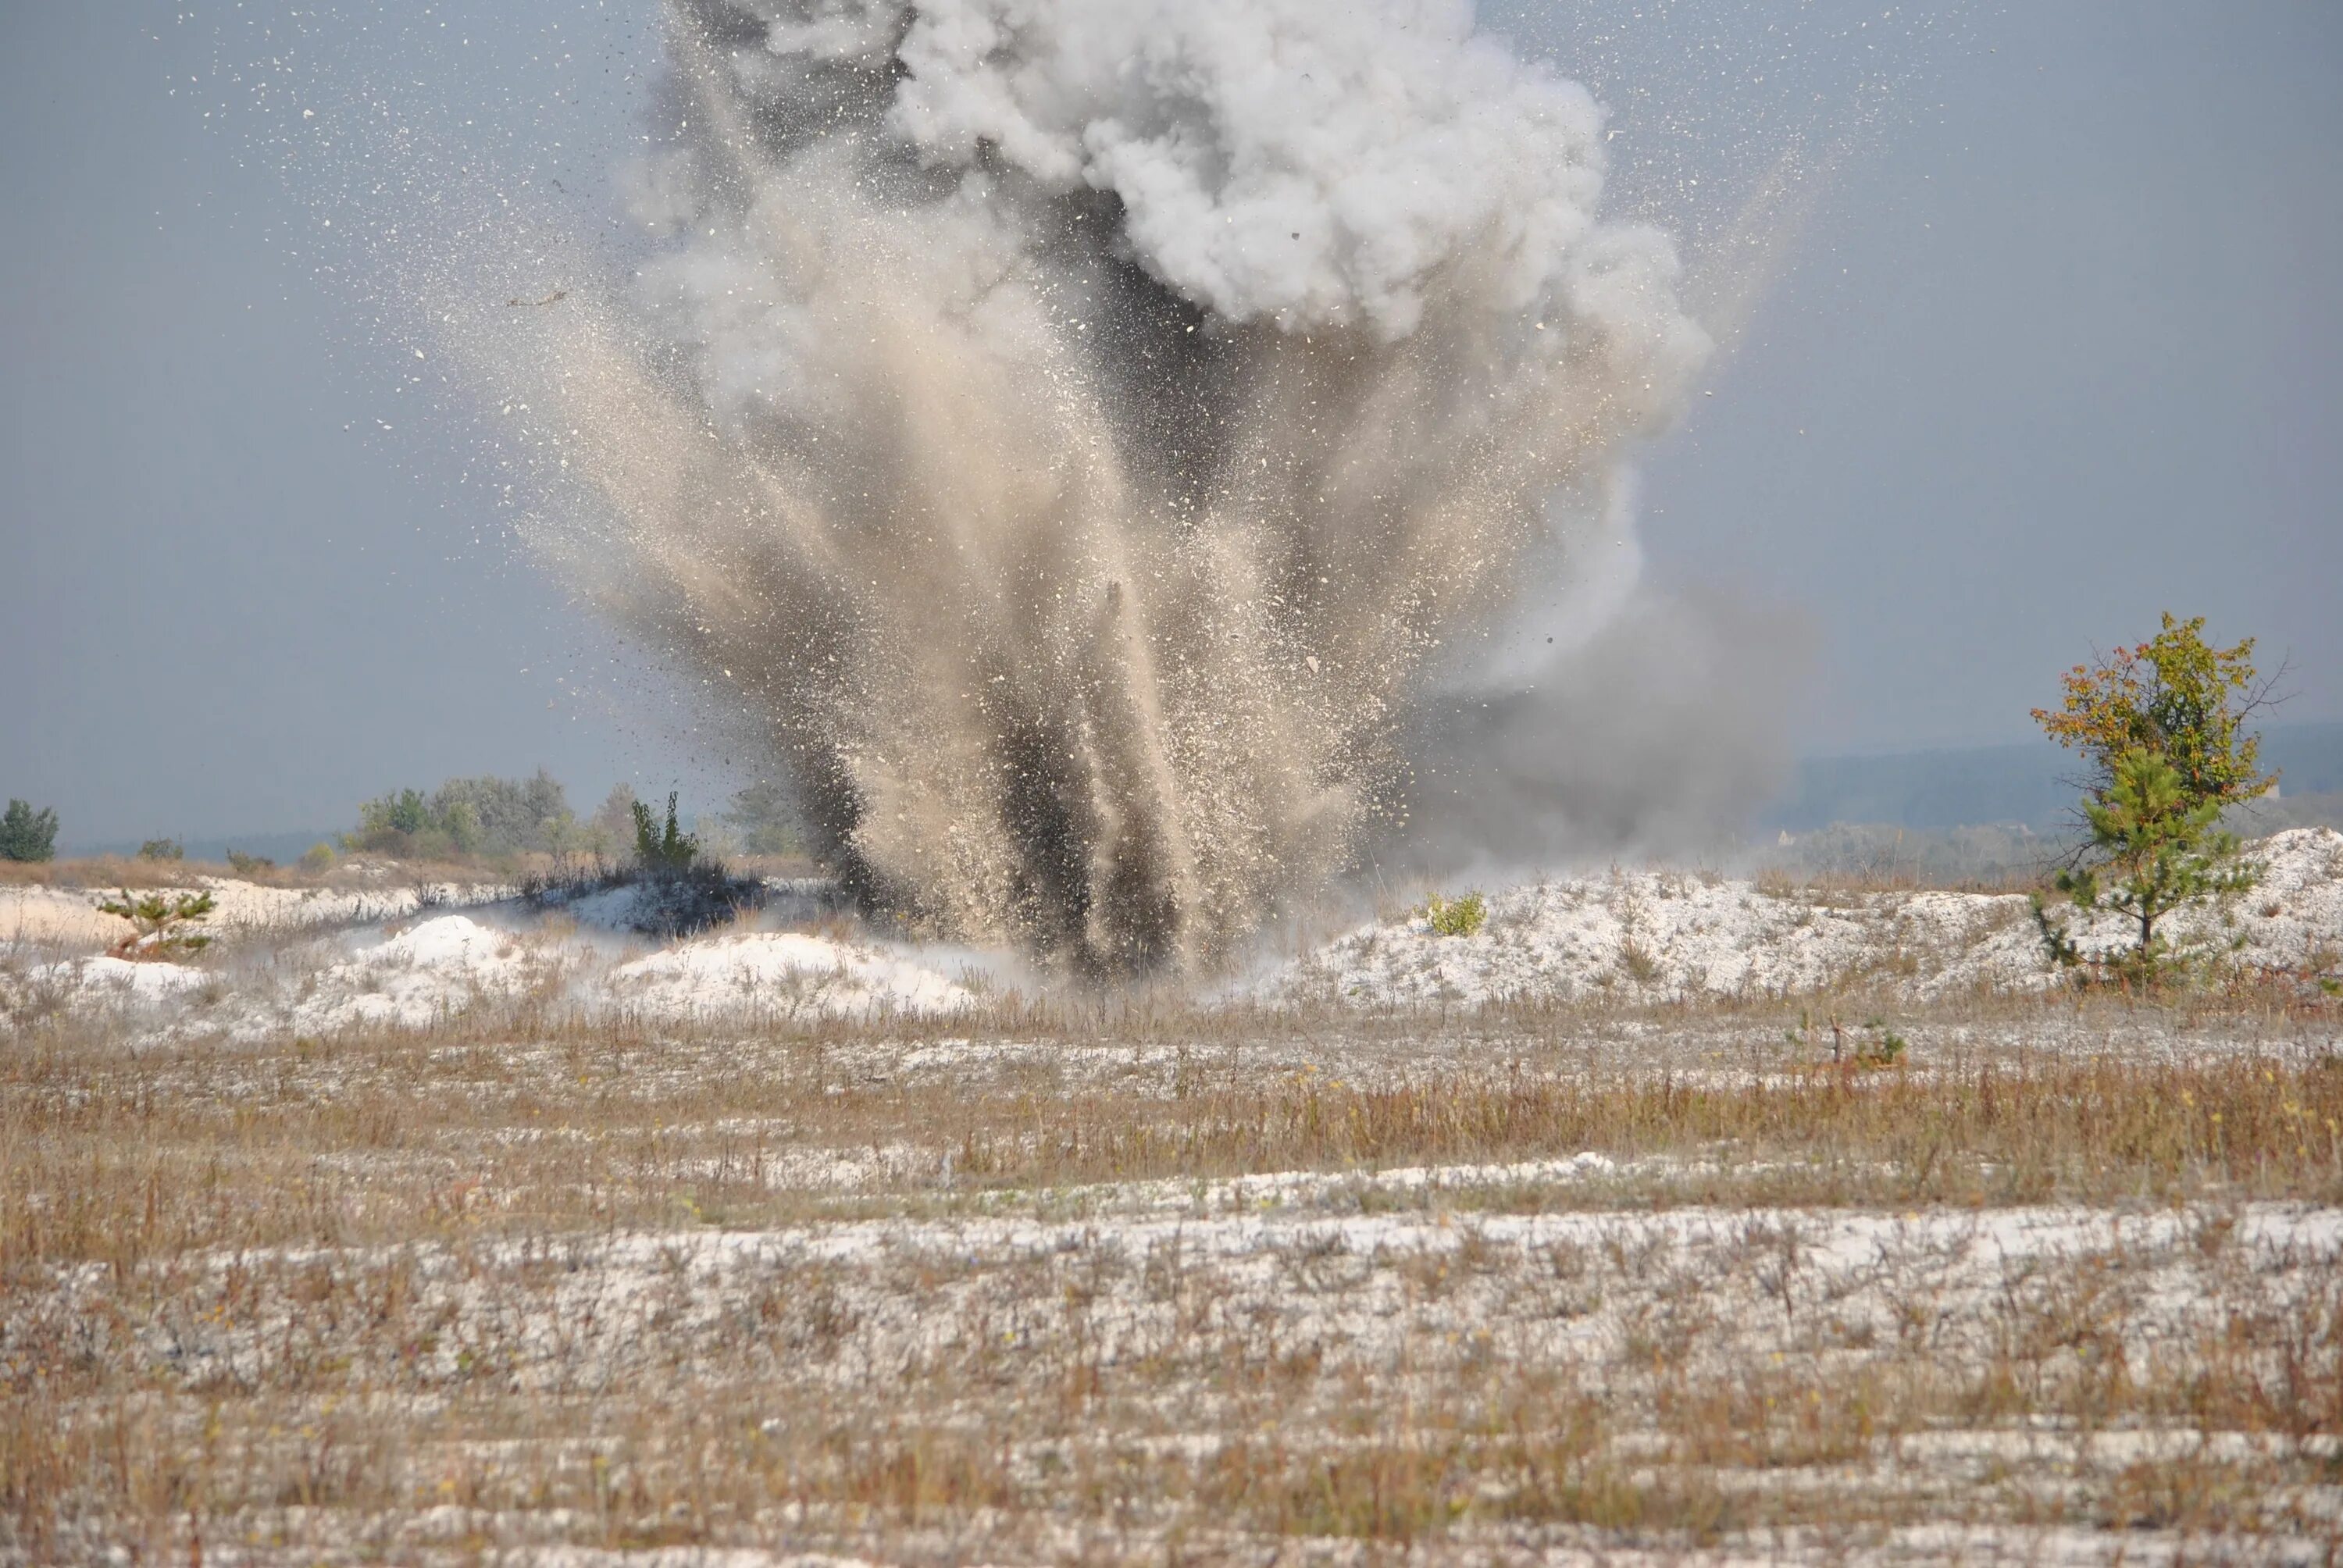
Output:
527,0,1708,973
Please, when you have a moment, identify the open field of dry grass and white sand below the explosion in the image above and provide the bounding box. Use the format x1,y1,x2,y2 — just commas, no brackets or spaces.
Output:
0,839,2343,1563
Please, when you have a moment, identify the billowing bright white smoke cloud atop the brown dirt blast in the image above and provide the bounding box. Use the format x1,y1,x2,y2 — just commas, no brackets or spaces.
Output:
872,0,1621,337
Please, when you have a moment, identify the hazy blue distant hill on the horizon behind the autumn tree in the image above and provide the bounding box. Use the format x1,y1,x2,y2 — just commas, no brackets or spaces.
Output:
1760,722,2343,832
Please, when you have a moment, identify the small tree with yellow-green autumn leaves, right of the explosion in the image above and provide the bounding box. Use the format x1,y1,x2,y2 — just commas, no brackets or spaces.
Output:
2034,614,2275,985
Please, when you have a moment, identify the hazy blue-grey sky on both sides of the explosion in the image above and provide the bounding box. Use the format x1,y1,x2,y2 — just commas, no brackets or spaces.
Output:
0,0,2343,844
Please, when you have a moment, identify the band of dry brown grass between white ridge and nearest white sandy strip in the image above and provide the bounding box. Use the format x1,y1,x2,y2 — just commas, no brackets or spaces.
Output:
0,1003,2343,1268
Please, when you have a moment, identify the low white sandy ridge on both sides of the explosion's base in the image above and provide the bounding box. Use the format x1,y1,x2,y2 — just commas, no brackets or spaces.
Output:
0,828,2343,1039
